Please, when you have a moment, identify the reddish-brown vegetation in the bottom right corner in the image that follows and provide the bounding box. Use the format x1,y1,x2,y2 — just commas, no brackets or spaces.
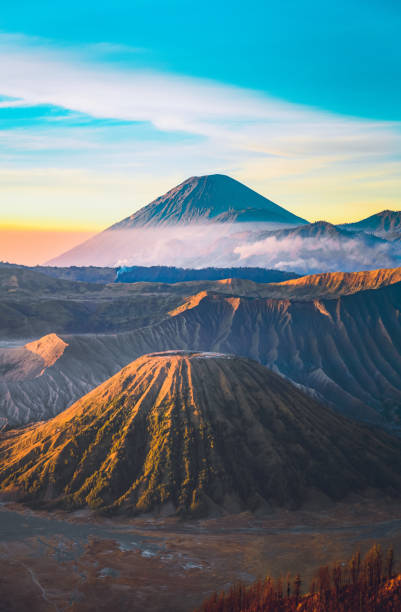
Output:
197,546,401,612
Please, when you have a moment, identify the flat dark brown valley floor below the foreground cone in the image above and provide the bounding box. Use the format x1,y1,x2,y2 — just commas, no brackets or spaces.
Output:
0,500,401,612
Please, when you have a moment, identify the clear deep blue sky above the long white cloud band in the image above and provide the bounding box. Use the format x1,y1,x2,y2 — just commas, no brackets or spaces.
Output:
0,0,401,120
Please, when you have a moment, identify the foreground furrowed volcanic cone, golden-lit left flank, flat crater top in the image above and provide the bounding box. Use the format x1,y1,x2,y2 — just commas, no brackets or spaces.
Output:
0,352,401,516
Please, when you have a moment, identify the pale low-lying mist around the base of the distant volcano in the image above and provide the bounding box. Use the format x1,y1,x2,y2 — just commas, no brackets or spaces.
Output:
51,223,401,273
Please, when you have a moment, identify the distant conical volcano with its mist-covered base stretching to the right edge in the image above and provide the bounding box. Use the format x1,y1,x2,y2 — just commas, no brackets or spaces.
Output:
45,174,401,274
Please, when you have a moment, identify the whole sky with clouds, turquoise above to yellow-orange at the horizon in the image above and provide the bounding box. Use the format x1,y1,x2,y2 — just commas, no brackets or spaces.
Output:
0,0,401,264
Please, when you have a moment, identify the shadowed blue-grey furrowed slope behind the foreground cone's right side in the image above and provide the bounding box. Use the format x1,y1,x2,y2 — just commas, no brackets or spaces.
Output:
157,283,401,424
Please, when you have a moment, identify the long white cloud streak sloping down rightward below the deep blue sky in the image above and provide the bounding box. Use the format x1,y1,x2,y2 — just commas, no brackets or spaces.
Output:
0,35,401,157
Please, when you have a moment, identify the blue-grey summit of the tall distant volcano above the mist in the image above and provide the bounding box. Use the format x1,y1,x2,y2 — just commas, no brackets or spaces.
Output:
110,174,307,229
